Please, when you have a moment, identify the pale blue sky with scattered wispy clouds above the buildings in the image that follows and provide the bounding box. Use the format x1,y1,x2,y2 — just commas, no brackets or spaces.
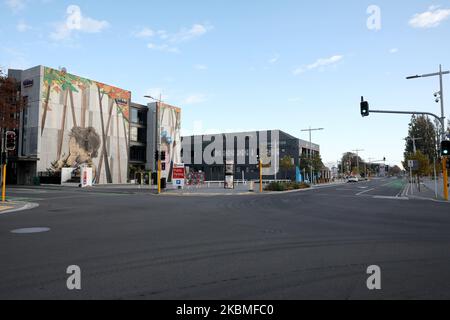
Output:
0,0,450,165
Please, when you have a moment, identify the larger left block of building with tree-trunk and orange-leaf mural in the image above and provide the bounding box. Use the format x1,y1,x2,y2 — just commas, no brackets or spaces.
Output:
8,66,131,184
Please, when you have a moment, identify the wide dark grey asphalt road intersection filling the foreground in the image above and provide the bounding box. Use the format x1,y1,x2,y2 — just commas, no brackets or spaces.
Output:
0,179,450,299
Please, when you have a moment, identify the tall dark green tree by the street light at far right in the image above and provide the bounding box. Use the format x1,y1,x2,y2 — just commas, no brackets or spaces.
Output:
404,116,437,163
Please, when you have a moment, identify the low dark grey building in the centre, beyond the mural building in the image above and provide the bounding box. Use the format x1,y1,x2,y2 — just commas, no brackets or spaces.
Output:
182,130,320,181
